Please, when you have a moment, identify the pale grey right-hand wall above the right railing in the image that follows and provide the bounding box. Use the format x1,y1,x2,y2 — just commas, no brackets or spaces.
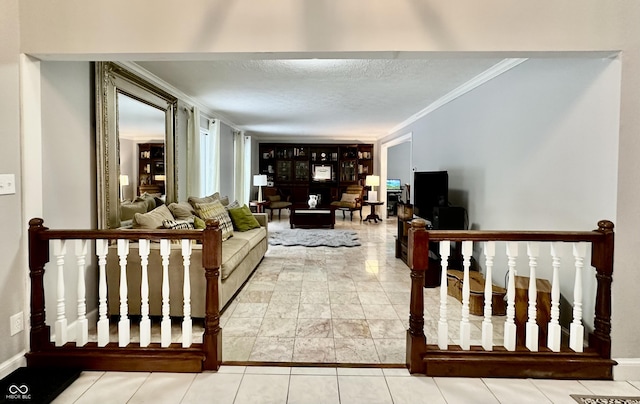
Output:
402,59,620,230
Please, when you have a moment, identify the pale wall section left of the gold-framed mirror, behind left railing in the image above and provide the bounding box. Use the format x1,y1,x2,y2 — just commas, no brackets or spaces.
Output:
40,62,97,330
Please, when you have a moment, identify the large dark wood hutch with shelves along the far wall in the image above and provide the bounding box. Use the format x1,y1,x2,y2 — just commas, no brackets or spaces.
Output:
258,143,373,203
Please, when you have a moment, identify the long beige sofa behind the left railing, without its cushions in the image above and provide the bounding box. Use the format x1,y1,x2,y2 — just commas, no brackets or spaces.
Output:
107,213,268,317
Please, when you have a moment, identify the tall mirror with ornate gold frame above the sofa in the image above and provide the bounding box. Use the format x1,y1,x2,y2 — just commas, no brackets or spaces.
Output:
95,62,178,229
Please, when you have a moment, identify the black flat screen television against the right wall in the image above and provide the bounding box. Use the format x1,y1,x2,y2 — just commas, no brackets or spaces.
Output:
411,171,449,222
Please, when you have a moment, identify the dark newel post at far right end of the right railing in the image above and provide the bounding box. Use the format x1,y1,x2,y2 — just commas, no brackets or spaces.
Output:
589,220,614,359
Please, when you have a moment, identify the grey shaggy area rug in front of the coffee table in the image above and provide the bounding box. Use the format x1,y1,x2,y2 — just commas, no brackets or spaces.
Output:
269,229,360,247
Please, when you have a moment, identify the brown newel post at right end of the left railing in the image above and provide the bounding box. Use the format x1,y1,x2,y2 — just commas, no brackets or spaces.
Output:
202,220,222,370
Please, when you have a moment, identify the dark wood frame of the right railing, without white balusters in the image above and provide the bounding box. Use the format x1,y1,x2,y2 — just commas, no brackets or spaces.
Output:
407,219,615,378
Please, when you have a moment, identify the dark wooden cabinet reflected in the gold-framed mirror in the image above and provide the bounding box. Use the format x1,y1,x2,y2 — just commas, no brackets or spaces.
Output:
137,143,166,195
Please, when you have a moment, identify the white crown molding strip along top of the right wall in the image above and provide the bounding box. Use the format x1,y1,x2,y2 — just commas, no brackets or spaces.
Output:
384,58,528,136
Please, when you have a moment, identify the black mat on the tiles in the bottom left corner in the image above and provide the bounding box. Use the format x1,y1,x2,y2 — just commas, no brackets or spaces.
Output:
0,367,80,403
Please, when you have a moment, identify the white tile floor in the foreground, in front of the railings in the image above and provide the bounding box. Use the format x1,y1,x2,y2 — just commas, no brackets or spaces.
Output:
53,366,640,404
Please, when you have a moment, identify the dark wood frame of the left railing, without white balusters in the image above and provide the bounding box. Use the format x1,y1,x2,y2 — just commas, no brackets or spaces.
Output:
27,218,222,371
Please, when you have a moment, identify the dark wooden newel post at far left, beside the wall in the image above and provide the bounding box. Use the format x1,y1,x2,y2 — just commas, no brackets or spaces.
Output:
29,218,51,352
